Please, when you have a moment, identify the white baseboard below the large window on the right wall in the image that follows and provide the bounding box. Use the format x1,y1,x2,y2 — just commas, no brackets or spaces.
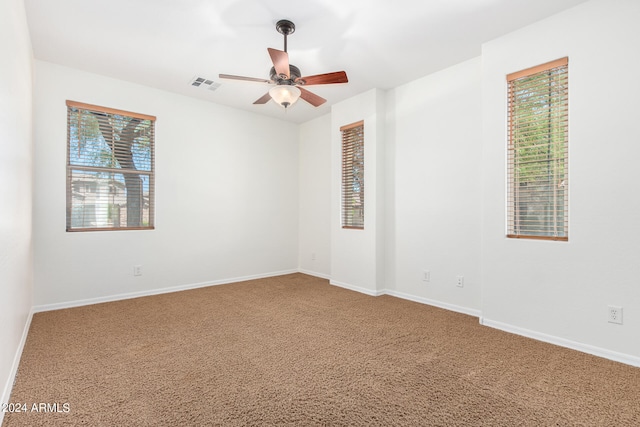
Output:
480,317,640,367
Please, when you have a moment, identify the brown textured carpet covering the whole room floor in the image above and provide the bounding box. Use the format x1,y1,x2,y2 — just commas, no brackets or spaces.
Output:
3,274,640,427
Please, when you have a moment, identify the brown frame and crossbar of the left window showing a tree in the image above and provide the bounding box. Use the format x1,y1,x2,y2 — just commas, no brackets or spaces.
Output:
66,100,156,233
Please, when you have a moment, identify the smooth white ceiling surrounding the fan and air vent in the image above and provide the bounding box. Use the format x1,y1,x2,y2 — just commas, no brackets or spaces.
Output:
25,0,586,123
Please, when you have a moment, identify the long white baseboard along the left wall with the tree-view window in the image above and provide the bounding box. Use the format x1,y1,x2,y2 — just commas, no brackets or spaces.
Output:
33,269,298,313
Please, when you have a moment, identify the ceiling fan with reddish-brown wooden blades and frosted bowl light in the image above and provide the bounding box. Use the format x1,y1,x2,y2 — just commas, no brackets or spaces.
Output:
220,19,349,109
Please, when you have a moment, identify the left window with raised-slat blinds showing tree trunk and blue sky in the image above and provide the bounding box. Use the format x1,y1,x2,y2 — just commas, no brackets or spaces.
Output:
67,101,155,231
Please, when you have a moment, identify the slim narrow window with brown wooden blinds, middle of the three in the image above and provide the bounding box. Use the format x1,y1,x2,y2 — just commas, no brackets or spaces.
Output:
340,121,364,229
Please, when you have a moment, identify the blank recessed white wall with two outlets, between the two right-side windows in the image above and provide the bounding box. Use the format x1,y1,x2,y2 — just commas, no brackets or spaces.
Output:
388,58,482,314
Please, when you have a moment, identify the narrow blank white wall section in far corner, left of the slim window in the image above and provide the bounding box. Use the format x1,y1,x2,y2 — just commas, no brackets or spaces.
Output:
298,114,331,278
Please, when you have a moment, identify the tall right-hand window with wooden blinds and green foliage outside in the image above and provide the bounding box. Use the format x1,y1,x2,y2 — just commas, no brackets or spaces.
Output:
507,58,569,241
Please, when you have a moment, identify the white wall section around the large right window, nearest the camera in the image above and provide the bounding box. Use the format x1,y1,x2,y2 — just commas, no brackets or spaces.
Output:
482,0,640,364
